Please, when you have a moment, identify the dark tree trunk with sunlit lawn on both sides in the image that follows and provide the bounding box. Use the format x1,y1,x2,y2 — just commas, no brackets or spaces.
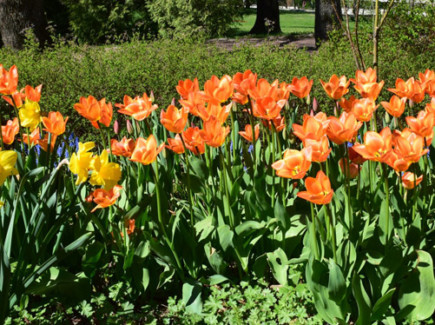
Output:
249,0,281,34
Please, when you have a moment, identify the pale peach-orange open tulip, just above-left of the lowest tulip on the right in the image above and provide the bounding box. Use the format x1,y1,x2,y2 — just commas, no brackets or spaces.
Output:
272,147,313,179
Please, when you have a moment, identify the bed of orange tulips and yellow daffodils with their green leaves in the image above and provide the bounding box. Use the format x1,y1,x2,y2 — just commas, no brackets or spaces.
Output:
0,60,435,324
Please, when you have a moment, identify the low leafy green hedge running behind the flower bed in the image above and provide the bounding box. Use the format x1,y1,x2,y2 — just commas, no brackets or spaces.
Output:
0,37,435,134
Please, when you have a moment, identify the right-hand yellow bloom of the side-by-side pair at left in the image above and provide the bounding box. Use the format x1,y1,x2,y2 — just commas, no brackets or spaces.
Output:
89,150,121,190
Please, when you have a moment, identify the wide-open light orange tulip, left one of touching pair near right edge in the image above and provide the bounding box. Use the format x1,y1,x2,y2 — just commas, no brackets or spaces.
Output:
353,127,393,162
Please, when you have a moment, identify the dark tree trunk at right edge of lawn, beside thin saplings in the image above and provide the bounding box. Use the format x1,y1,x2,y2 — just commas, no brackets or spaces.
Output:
314,0,343,44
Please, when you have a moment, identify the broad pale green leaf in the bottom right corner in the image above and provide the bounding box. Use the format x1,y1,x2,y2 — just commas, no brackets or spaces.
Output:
399,250,435,320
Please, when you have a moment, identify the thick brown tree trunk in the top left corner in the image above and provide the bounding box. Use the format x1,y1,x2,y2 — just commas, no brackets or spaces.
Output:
0,0,49,49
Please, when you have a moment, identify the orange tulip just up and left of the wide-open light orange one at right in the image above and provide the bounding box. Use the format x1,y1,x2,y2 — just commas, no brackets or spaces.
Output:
326,112,362,144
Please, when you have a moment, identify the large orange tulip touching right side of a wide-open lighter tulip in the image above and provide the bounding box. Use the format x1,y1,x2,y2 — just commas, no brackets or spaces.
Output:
393,129,429,162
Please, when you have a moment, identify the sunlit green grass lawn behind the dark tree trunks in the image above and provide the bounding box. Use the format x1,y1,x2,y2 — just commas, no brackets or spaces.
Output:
228,9,364,37
